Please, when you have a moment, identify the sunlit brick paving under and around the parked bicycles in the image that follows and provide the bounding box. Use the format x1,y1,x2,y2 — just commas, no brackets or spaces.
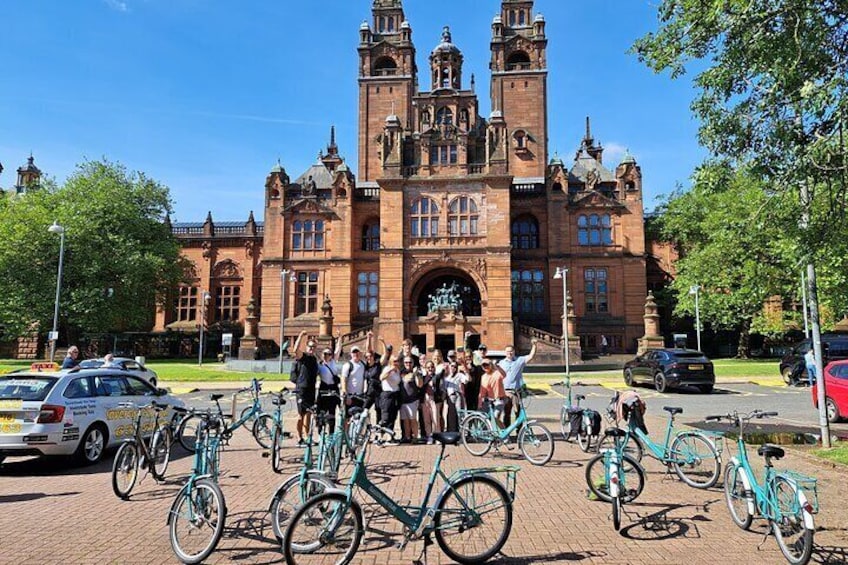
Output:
0,415,848,564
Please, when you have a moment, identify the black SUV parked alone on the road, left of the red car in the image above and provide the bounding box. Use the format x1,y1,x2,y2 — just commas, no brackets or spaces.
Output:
624,349,715,393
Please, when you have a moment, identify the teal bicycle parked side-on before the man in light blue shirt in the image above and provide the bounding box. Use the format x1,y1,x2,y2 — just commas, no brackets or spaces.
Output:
459,394,554,465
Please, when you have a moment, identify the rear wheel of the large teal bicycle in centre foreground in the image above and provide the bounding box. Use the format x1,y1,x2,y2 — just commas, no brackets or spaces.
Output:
434,475,512,563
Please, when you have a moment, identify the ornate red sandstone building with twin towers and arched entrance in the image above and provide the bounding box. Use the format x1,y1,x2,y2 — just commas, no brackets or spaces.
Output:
155,0,647,359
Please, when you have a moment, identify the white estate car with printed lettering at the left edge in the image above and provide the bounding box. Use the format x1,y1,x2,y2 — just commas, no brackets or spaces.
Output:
0,368,185,464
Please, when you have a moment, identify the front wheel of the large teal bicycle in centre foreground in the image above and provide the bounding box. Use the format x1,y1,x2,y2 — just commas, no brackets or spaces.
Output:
283,486,364,565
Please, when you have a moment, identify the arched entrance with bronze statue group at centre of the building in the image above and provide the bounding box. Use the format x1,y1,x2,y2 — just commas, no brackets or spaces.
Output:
408,267,483,355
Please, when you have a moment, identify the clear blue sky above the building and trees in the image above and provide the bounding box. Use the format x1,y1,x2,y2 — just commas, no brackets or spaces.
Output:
0,0,705,221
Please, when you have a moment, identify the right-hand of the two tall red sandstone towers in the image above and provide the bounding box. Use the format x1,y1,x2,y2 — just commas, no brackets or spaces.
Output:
489,0,548,179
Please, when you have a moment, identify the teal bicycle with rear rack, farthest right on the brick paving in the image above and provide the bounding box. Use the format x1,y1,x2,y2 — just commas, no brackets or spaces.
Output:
707,410,819,565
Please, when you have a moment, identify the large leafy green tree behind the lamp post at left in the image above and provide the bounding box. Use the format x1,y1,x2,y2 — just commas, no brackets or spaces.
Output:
0,160,183,338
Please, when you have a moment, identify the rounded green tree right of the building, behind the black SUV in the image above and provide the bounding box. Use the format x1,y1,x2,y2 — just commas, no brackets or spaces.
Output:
659,161,797,357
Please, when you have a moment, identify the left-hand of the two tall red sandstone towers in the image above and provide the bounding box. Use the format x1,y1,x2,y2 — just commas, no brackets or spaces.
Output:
358,0,417,184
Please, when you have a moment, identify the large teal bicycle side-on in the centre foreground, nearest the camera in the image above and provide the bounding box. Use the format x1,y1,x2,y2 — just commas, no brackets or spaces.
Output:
283,425,520,565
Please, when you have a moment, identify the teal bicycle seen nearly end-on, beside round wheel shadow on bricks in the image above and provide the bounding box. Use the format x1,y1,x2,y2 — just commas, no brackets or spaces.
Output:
586,428,645,531
